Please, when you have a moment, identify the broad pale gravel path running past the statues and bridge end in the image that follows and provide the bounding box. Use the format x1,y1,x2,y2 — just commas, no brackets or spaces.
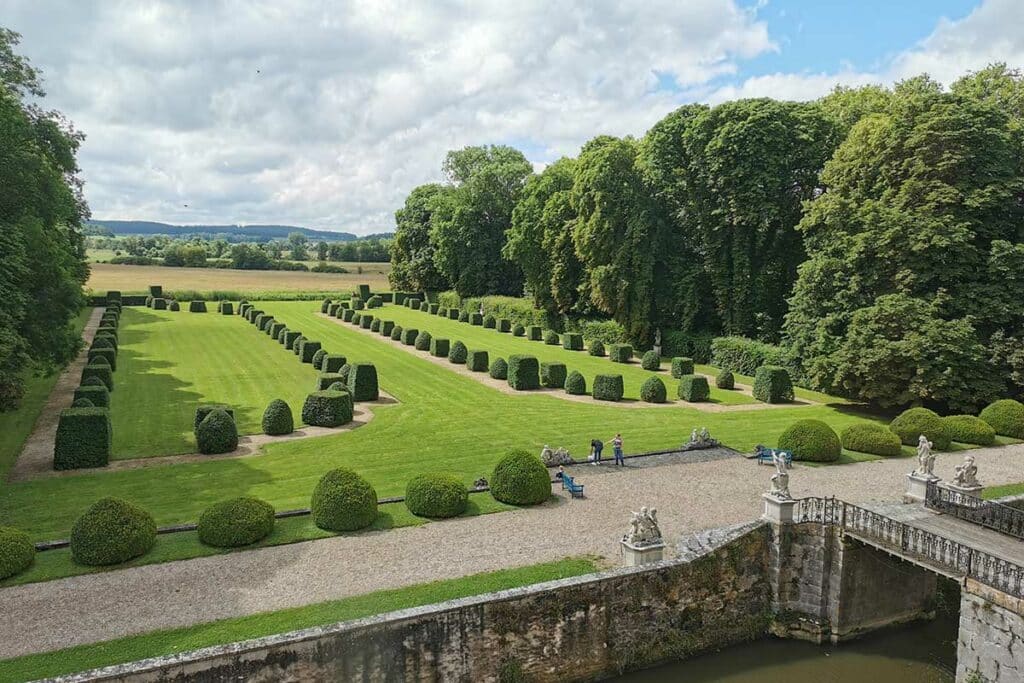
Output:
0,444,1024,658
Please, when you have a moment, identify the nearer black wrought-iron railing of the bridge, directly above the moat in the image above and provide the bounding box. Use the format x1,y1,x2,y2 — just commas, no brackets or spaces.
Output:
794,498,1024,598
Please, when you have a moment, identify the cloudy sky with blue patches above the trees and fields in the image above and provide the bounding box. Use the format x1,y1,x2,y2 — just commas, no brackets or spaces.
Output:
8,0,1024,234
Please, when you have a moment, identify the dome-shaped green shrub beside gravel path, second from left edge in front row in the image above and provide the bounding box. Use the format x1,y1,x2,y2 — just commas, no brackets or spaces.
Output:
71,498,157,566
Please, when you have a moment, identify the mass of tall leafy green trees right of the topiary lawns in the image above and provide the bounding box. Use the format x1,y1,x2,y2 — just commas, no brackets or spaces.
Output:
391,65,1024,411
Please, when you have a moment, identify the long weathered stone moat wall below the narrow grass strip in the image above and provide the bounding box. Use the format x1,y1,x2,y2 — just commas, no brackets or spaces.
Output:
65,523,772,682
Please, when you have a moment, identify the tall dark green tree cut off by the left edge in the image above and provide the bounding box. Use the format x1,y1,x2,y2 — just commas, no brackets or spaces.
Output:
0,28,88,410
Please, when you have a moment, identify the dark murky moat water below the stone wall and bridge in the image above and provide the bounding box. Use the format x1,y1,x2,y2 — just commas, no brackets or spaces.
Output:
615,615,956,683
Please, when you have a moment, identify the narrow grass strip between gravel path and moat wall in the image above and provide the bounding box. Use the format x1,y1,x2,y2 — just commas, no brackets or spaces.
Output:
0,557,598,682
